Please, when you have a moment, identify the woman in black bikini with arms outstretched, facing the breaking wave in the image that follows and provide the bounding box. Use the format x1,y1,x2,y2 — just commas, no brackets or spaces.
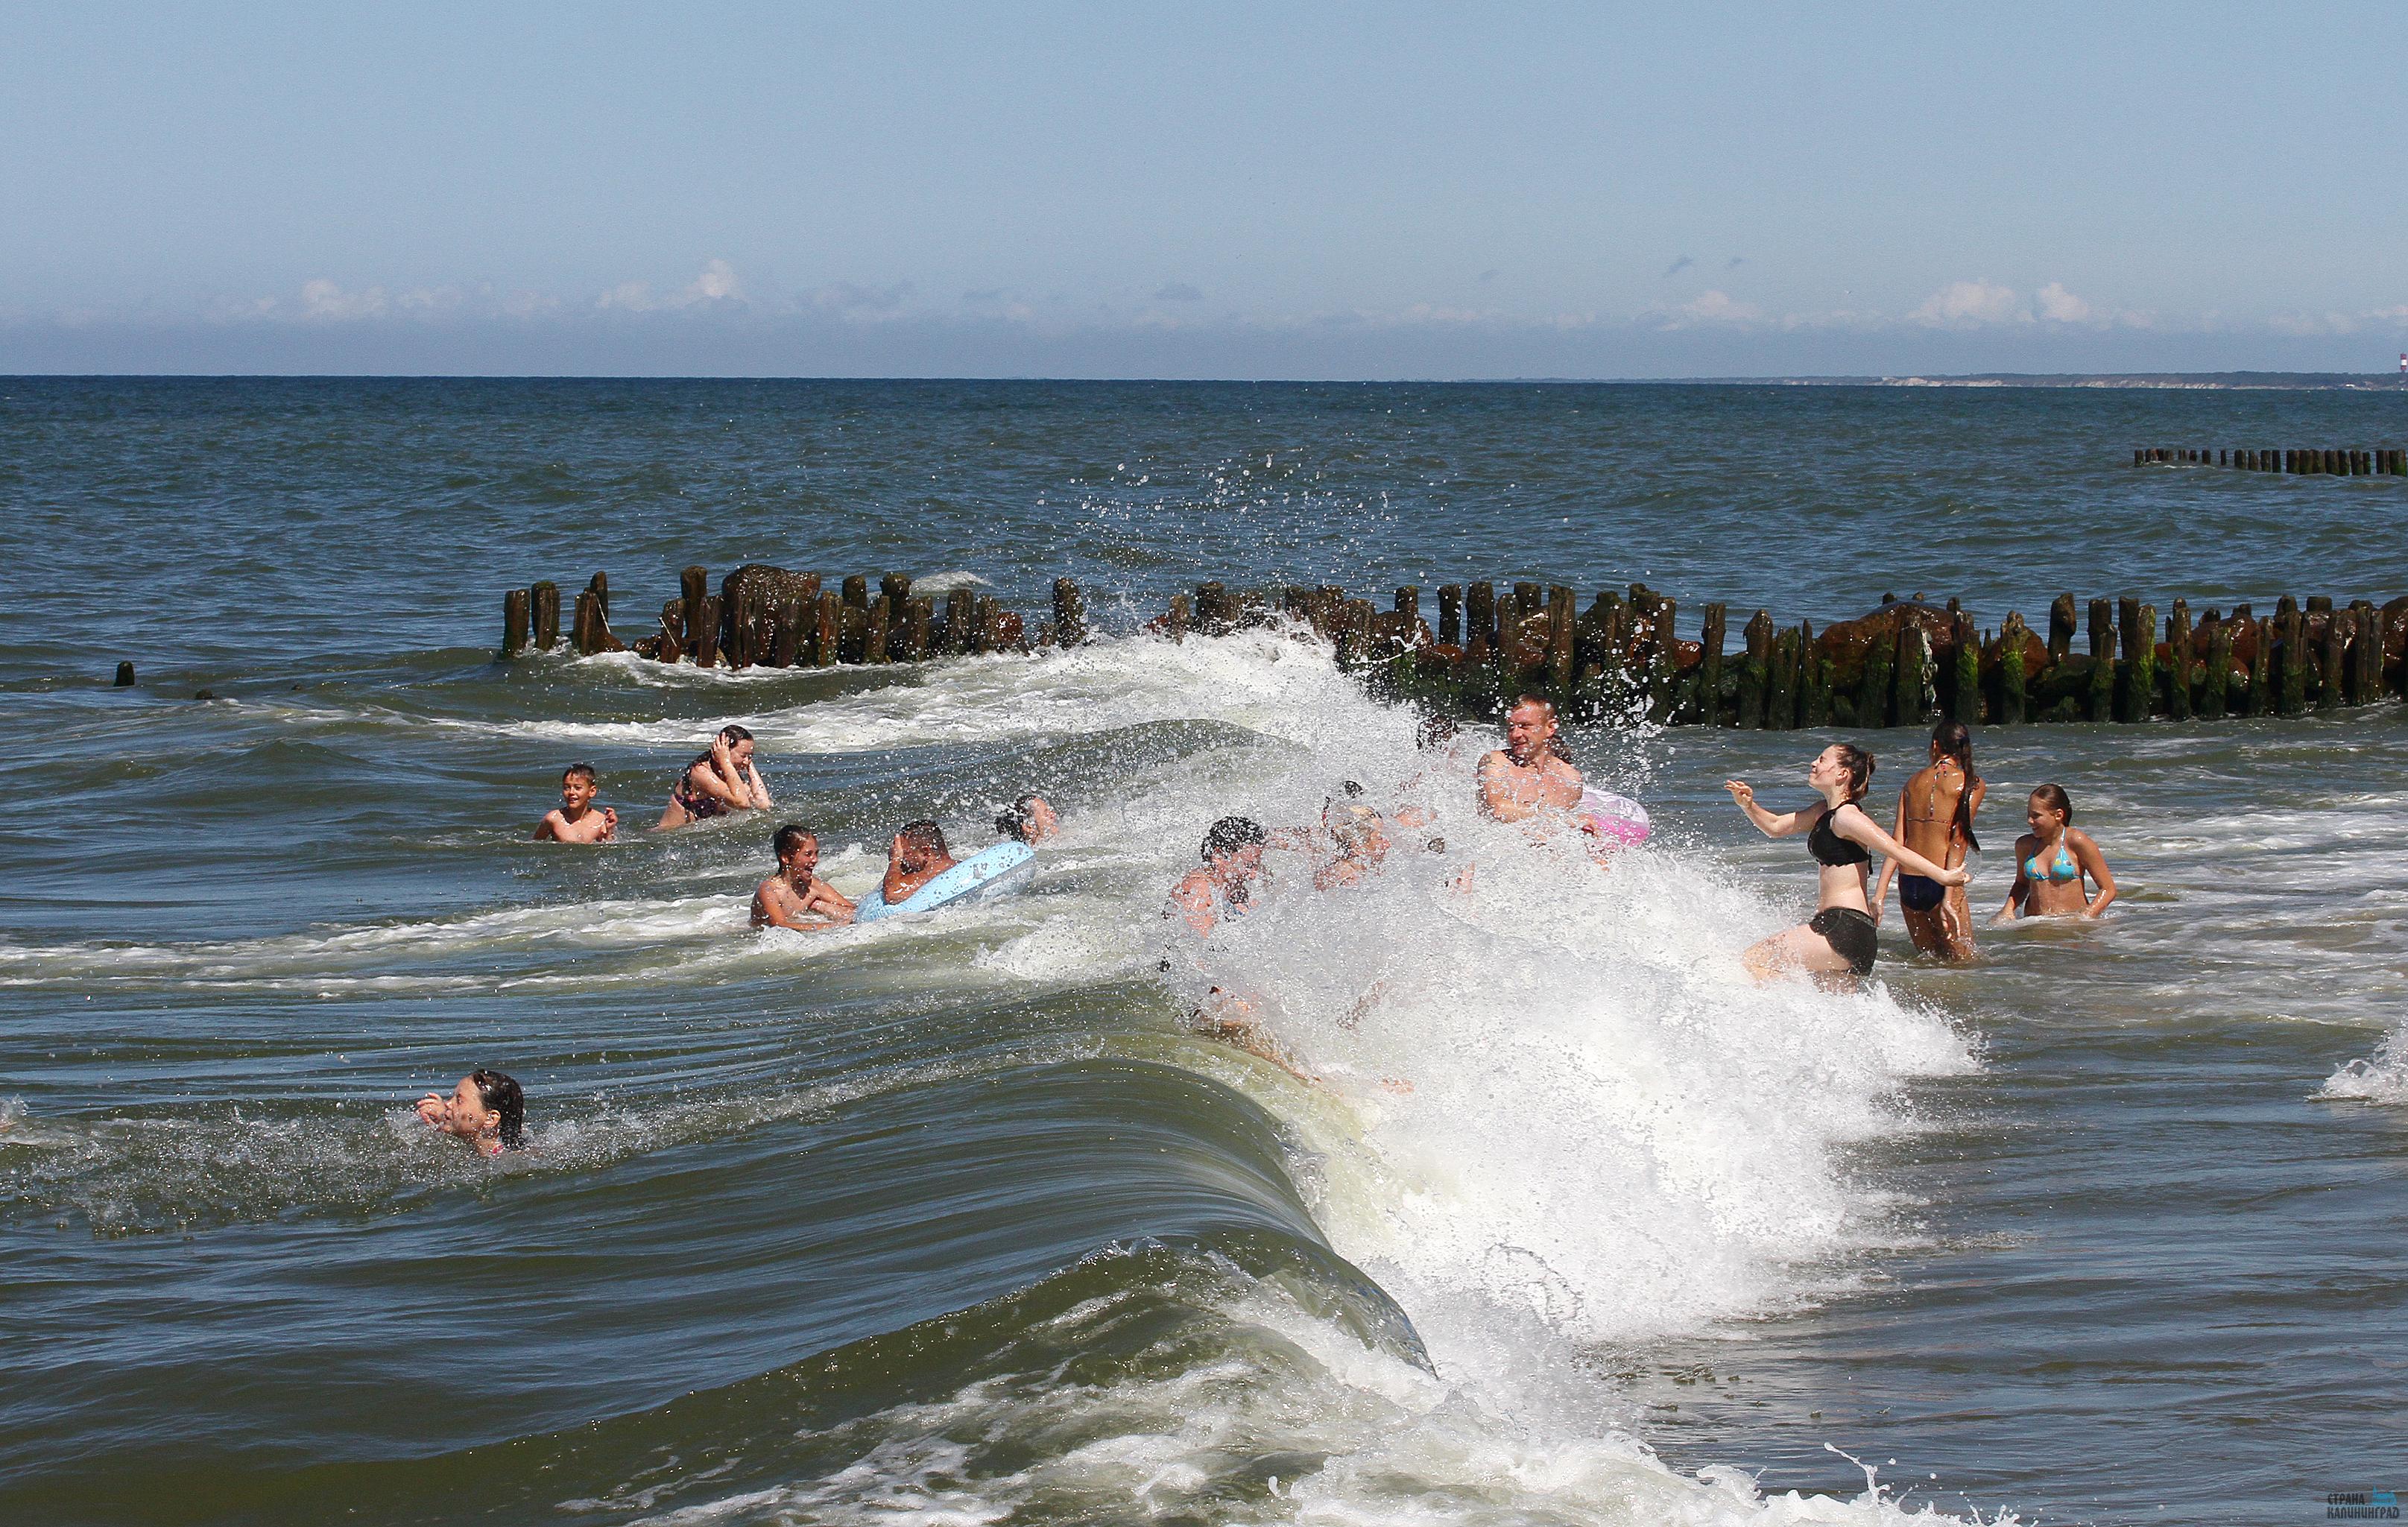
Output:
1722,742,1970,993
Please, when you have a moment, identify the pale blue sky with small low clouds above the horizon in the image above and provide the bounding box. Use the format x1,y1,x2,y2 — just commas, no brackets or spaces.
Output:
0,2,2408,378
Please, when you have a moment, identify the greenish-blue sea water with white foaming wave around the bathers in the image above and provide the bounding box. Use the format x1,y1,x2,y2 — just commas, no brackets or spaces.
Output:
0,370,2408,1525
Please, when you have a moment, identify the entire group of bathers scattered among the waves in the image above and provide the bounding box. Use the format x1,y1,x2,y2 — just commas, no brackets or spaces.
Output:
438,694,2117,1154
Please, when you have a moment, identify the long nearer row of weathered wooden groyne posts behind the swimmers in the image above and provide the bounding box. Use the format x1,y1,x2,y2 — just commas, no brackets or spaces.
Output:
501,563,2408,730
